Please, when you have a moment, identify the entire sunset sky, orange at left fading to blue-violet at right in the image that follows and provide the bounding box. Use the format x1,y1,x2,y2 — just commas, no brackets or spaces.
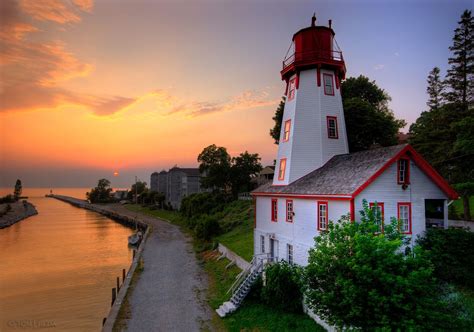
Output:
0,0,468,187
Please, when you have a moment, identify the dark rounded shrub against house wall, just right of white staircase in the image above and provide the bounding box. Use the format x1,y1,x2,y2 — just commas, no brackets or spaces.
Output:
260,261,303,312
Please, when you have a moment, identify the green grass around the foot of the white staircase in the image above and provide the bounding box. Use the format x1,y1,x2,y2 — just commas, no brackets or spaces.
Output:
202,251,324,331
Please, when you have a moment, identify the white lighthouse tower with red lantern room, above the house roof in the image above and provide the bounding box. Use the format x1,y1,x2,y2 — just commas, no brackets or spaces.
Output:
273,16,349,185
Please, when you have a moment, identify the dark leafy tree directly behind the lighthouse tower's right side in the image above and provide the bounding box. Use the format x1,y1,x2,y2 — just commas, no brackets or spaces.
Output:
341,75,406,152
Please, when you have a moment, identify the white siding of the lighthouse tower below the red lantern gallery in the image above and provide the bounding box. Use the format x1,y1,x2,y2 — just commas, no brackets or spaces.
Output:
273,69,348,185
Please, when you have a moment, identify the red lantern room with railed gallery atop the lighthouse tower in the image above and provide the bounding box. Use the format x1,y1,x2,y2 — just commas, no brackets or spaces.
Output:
281,15,346,81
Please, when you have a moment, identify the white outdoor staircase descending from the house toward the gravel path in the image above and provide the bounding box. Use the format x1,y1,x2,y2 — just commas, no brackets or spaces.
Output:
216,254,268,317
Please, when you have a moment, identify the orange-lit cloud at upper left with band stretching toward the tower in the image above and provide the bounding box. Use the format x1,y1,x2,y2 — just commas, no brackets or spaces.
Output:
0,0,279,117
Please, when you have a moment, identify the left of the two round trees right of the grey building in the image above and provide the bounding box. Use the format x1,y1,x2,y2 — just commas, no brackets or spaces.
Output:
198,144,232,191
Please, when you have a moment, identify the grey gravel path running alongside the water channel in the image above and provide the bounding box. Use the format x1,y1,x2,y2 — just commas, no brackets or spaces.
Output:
101,204,211,332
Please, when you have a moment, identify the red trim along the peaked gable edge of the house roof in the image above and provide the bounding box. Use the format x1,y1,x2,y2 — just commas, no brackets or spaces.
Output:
352,145,459,199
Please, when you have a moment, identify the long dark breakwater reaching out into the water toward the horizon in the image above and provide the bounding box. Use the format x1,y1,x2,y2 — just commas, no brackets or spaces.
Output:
46,195,148,232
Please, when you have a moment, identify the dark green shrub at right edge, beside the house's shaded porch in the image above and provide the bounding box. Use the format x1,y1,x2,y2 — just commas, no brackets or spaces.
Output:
417,228,474,289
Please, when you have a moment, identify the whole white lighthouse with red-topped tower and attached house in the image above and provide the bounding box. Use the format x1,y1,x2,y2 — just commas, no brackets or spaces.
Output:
252,18,458,265
